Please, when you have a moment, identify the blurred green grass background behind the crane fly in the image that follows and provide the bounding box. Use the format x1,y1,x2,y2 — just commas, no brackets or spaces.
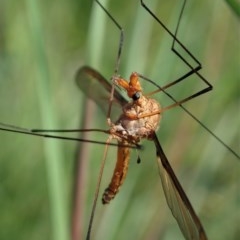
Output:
0,0,240,240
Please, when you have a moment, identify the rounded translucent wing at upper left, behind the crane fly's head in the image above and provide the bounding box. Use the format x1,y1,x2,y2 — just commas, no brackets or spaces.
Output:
76,66,128,119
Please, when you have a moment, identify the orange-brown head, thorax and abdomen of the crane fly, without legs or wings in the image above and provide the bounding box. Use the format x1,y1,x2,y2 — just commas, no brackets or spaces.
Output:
102,73,161,204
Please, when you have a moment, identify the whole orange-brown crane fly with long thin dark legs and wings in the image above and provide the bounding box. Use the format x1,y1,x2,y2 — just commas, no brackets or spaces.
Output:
0,1,239,239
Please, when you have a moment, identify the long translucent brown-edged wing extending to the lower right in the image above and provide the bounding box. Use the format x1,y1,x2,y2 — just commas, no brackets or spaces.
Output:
153,134,207,240
